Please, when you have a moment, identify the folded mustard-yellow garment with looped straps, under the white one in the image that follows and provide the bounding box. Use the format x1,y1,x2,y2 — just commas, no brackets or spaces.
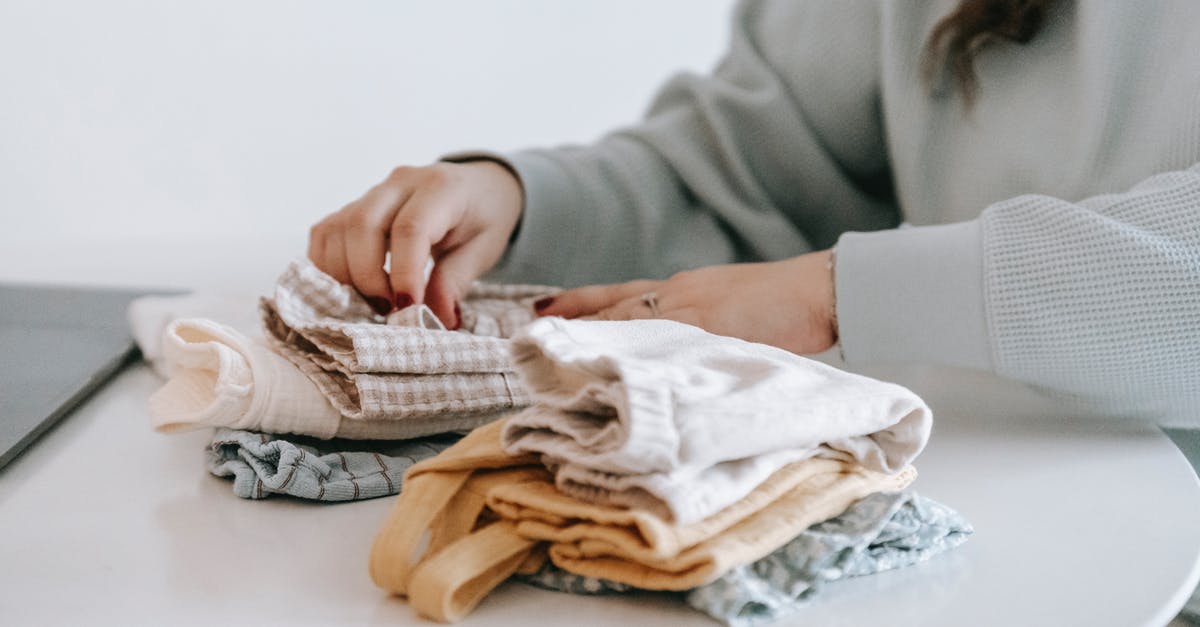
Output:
371,420,916,620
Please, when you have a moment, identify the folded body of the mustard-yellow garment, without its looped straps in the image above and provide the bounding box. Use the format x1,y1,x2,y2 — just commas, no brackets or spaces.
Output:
488,459,916,590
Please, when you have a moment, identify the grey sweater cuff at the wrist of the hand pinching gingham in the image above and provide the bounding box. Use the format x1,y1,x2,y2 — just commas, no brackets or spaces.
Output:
440,150,598,287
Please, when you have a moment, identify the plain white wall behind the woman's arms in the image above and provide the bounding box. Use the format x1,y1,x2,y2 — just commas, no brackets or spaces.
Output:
0,0,732,287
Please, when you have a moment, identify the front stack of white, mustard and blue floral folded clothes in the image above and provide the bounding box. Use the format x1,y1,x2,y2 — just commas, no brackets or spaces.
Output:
371,318,970,622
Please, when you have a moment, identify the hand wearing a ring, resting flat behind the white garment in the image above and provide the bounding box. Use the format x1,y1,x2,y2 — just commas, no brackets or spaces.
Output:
538,251,838,354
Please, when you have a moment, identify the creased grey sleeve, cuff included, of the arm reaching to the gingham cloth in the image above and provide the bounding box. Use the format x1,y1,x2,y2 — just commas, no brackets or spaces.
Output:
444,0,899,286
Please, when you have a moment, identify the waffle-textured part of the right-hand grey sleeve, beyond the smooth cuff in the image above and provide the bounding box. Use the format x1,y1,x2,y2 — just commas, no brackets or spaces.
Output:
980,165,1200,424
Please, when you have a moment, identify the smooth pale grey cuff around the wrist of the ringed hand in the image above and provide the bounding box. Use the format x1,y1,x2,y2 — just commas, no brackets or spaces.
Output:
835,221,992,371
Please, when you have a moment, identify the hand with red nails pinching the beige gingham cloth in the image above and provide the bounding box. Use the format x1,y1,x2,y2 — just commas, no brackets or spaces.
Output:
308,161,524,329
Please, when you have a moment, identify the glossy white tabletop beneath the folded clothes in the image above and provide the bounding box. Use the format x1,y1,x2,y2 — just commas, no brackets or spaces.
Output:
0,343,1200,627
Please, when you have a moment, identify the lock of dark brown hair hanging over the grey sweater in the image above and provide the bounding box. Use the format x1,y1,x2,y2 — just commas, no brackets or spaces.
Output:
922,0,1054,106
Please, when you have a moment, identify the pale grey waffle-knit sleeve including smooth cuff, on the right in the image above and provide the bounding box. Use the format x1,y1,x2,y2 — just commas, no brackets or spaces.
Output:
836,165,1200,426
